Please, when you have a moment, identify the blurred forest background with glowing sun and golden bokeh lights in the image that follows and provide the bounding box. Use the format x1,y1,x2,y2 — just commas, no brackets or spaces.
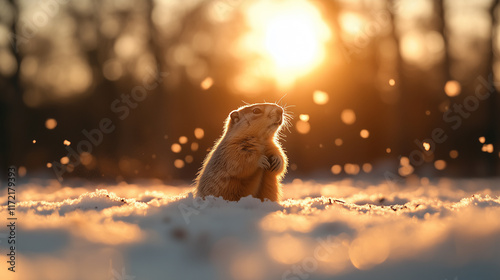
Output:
0,0,500,182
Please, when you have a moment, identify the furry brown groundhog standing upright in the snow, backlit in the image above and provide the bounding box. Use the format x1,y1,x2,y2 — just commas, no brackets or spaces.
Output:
195,103,289,201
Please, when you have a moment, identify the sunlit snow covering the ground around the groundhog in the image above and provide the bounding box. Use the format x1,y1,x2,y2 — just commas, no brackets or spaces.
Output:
0,179,500,280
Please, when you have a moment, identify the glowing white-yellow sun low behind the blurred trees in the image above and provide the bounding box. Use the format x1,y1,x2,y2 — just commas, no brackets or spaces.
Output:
240,0,331,86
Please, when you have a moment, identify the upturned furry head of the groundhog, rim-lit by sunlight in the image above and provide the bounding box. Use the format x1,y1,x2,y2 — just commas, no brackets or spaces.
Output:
227,103,285,138
